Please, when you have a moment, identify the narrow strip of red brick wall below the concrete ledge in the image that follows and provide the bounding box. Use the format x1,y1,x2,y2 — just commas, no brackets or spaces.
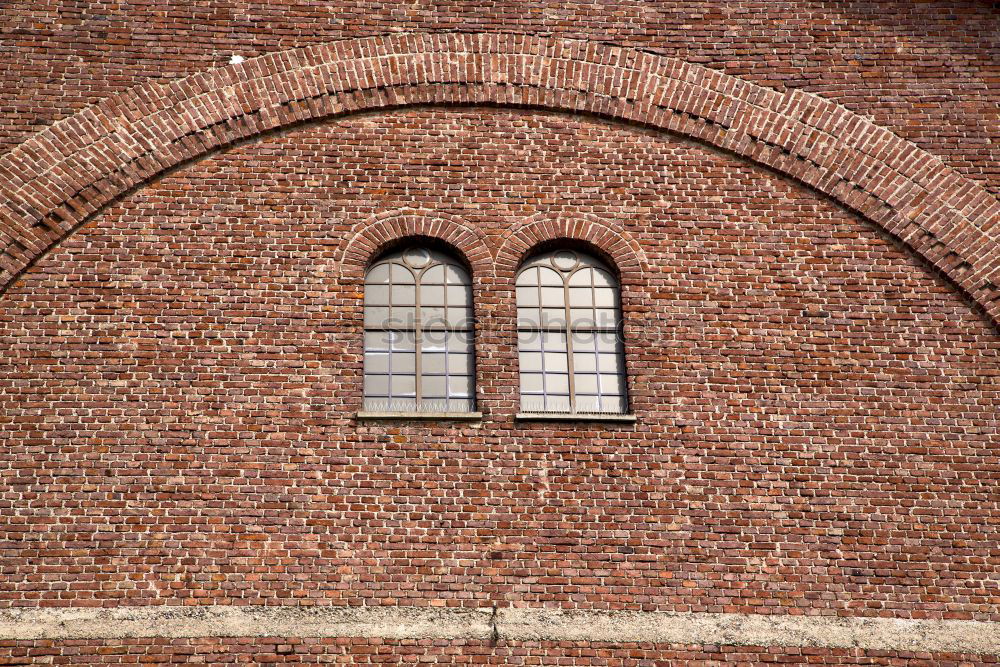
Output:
0,638,996,667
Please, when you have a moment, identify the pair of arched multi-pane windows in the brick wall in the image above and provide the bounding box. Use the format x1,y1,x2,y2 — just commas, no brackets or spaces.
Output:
364,247,628,416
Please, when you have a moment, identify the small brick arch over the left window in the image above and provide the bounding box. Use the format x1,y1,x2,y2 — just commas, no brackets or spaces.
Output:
335,208,493,281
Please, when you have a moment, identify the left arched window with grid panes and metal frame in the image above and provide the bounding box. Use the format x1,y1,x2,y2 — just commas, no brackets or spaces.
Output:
364,247,475,413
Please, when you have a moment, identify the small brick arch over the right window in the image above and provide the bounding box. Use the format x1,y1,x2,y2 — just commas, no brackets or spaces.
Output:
496,213,648,287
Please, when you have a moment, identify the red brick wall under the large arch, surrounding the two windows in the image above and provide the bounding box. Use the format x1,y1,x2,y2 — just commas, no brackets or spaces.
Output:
0,109,1000,618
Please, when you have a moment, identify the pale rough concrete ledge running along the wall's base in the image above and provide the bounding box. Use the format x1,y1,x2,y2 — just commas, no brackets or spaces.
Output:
0,606,1000,654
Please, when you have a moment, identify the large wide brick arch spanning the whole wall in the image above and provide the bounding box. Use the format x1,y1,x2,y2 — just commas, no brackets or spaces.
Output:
0,33,1000,324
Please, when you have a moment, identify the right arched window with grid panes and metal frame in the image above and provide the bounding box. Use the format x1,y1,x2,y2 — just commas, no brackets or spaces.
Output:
517,250,628,415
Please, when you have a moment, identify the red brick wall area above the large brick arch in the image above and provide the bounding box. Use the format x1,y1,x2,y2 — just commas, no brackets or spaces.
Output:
0,0,1000,192
